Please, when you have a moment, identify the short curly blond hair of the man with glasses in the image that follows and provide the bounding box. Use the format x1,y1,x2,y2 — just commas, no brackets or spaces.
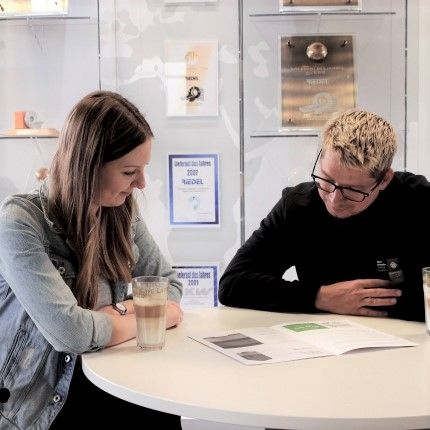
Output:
321,110,397,179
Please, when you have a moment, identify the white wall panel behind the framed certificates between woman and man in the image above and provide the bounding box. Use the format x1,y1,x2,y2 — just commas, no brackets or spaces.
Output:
100,0,240,270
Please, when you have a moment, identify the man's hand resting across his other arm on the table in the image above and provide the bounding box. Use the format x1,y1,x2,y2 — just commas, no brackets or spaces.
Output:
315,279,402,317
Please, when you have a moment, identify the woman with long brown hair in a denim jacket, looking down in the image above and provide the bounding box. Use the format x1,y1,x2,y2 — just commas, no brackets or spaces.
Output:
0,91,182,430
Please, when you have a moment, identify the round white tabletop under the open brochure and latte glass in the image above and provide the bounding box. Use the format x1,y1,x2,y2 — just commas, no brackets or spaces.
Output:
83,307,430,430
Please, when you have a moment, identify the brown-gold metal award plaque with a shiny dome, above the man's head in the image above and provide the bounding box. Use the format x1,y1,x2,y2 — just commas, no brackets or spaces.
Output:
280,34,356,128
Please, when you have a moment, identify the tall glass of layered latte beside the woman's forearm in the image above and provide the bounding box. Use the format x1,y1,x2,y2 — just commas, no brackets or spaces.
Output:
131,276,169,350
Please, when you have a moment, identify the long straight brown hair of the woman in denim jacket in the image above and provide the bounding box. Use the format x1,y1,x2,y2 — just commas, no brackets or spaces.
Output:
48,91,153,309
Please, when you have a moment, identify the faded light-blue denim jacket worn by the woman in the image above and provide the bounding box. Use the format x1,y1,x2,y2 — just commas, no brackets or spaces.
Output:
0,186,182,430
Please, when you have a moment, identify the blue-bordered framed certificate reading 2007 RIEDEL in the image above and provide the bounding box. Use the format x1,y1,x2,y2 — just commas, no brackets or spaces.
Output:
168,154,220,227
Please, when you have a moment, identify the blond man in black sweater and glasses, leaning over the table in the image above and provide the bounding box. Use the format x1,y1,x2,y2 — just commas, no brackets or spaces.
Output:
219,110,430,320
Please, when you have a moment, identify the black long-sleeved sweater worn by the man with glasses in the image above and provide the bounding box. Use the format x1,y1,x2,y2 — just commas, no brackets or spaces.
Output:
219,172,430,321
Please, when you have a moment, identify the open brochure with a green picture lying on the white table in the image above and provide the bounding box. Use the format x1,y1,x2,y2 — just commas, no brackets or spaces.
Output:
190,320,416,364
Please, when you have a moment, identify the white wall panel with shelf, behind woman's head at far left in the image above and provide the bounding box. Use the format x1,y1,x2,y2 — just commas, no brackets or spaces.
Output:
0,0,99,200
